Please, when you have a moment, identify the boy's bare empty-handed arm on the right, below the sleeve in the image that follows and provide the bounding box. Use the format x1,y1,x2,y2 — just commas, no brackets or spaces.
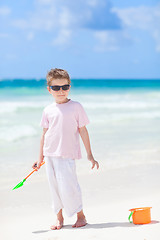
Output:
79,126,99,169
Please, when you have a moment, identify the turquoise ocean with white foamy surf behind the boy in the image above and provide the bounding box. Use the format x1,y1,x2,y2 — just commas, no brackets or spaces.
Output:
0,79,160,182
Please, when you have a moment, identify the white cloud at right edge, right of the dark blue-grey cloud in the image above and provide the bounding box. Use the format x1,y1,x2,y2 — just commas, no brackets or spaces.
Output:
113,4,160,52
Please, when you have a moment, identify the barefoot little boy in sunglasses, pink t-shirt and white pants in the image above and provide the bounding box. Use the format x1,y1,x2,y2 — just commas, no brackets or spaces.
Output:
32,68,99,230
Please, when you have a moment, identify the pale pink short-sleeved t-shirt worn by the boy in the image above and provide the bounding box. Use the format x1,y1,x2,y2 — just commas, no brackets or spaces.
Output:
40,100,89,159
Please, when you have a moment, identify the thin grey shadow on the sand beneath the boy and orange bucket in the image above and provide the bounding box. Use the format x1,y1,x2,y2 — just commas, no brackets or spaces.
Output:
32,221,160,234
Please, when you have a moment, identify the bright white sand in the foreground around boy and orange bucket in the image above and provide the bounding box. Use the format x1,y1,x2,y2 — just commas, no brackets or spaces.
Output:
0,164,160,240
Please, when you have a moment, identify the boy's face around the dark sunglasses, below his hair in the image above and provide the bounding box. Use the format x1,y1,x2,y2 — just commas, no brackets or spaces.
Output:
47,78,71,103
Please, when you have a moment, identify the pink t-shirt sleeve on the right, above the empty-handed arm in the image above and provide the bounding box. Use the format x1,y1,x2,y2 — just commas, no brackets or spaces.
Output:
76,104,89,128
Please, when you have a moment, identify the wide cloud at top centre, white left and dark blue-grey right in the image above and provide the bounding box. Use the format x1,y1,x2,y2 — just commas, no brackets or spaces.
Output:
13,0,120,31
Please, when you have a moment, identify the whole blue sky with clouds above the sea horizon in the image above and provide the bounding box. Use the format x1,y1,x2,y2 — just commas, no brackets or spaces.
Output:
0,0,160,79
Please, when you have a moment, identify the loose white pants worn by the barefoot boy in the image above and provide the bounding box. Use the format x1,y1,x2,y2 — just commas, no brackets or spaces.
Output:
45,157,82,217
